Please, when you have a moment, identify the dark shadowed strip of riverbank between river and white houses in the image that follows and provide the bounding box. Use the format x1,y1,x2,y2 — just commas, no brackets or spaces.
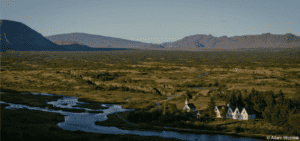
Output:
95,111,274,140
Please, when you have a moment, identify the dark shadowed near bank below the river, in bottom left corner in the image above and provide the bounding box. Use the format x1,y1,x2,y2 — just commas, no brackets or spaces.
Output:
0,103,188,141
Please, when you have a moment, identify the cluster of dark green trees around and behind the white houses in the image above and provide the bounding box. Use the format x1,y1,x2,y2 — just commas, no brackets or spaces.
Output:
208,89,300,135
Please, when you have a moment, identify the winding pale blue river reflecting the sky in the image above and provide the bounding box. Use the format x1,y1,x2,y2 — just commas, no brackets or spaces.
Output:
0,92,266,141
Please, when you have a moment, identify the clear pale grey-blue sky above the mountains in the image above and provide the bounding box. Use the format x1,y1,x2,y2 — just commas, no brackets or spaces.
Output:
0,0,300,43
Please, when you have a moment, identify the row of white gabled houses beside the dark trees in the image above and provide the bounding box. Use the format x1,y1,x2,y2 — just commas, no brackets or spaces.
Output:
215,104,255,120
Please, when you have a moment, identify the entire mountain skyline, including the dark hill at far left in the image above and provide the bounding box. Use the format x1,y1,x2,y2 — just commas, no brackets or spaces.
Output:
0,20,300,51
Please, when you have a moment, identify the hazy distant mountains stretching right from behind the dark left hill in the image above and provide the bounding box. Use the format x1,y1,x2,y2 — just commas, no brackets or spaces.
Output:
46,33,300,49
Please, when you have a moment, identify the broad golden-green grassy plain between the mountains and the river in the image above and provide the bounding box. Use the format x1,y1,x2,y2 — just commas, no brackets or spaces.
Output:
1,49,300,110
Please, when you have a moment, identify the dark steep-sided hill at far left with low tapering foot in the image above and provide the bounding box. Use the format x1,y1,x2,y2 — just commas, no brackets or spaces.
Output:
0,20,128,52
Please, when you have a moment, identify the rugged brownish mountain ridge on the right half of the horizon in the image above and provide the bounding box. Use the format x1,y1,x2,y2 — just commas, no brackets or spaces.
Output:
169,33,300,48
